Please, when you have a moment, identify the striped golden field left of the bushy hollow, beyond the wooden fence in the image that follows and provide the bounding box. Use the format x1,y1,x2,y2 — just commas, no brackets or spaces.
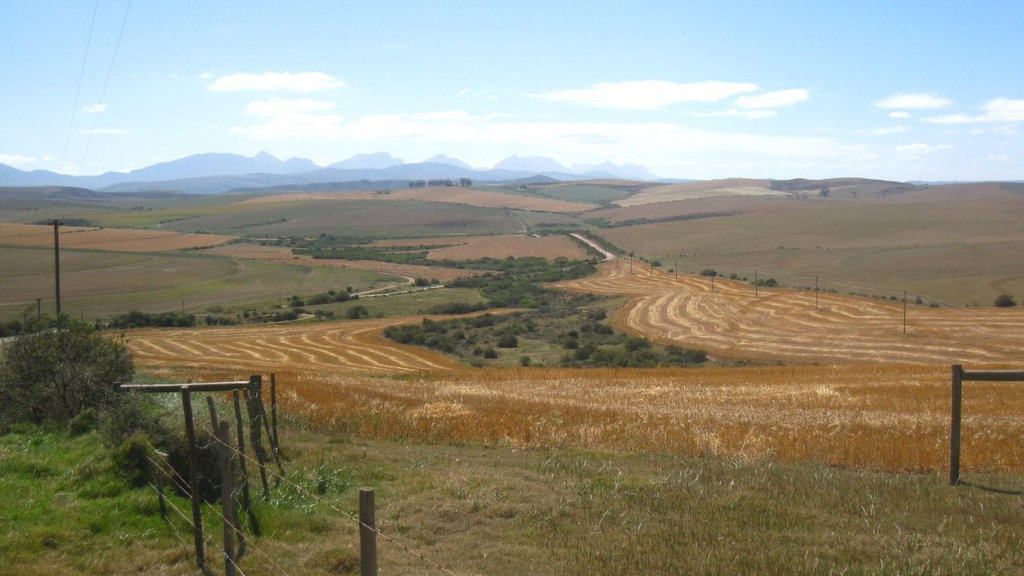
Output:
128,318,461,376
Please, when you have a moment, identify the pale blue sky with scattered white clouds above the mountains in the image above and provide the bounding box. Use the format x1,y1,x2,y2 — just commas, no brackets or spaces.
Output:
0,0,1024,181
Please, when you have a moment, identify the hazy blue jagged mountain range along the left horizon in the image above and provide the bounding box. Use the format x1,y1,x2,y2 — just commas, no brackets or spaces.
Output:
0,152,657,194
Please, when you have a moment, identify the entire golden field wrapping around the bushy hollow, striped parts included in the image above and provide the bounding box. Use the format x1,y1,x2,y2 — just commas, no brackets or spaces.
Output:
128,261,1024,474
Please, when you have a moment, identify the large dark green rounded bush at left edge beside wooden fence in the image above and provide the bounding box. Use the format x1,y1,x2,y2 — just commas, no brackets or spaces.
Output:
0,316,135,425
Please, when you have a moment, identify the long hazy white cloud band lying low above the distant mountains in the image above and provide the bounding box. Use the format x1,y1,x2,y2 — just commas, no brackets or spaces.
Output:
231,112,850,166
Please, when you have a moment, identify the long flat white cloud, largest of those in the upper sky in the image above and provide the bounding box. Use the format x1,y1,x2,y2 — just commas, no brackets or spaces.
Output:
529,80,758,110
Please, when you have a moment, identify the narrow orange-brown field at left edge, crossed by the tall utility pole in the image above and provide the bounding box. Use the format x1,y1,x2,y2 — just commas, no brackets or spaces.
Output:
0,223,234,252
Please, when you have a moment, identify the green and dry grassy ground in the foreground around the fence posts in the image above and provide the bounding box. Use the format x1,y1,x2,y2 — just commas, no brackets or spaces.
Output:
0,429,1024,575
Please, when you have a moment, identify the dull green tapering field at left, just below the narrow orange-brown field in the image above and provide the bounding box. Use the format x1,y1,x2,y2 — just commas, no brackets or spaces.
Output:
0,247,403,319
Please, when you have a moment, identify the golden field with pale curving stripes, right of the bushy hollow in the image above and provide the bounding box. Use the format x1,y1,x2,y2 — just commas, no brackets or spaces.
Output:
558,259,1024,364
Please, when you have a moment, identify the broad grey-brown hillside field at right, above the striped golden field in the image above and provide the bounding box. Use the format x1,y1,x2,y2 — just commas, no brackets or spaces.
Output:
595,184,1024,305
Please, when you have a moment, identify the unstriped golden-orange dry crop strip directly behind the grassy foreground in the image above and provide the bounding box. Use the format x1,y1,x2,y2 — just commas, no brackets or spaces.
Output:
197,366,1024,472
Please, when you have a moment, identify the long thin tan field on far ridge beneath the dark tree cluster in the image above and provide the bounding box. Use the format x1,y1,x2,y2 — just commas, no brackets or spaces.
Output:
240,187,596,213
